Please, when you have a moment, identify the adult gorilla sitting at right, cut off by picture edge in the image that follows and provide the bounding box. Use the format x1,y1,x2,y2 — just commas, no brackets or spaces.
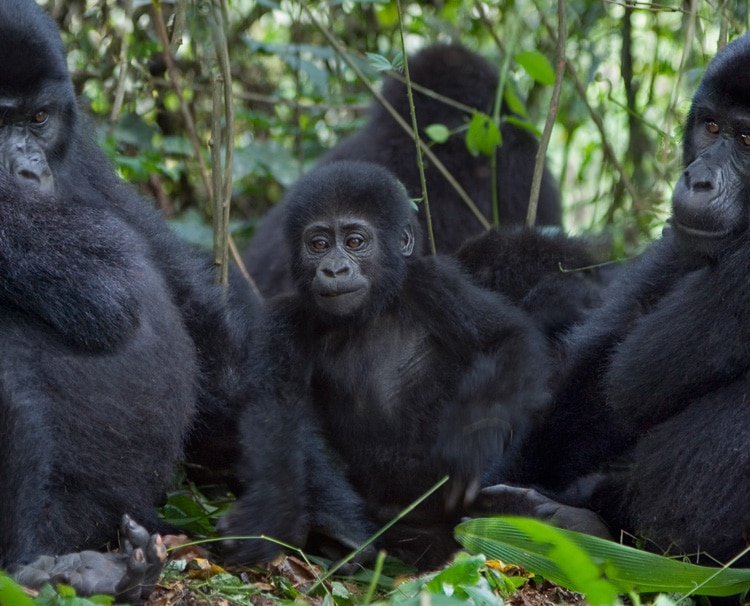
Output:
480,35,750,566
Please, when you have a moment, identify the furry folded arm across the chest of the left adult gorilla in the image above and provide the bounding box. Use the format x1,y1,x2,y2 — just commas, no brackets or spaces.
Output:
0,171,140,352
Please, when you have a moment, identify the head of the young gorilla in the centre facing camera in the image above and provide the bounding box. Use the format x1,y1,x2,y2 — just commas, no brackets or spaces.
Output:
285,162,419,319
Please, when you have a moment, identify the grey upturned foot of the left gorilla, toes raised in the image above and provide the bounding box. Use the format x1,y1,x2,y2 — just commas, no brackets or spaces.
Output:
13,514,167,603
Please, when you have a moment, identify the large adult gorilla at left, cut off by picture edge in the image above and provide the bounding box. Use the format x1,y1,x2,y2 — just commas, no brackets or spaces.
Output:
0,0,253,601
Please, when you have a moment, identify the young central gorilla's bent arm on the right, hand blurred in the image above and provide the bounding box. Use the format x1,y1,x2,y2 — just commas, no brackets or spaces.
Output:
411,257,551,509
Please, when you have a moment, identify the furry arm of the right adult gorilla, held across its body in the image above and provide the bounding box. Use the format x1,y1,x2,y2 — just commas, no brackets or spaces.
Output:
607,230,750,432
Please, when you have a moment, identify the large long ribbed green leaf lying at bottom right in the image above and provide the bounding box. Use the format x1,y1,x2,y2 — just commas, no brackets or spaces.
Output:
456,517,750,604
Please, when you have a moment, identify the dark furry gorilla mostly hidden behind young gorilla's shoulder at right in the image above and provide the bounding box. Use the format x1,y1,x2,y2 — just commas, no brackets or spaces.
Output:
455,226,612,345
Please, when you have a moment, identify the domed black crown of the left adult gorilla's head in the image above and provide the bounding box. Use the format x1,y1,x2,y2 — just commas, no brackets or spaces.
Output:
0,0,72,94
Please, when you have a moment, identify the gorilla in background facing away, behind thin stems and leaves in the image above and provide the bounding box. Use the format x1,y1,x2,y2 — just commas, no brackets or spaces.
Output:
244,44,561,295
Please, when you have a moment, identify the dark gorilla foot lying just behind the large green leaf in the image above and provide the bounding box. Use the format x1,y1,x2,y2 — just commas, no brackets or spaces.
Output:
470,484,612,539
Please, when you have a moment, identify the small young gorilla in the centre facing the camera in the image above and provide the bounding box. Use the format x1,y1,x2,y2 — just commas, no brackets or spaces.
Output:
224,162,549,567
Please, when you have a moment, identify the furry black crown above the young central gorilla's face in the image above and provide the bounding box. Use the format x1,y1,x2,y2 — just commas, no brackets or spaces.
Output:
285,161,417,240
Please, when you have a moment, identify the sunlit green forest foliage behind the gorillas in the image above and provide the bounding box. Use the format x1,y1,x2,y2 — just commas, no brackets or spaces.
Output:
40,0,749,254
